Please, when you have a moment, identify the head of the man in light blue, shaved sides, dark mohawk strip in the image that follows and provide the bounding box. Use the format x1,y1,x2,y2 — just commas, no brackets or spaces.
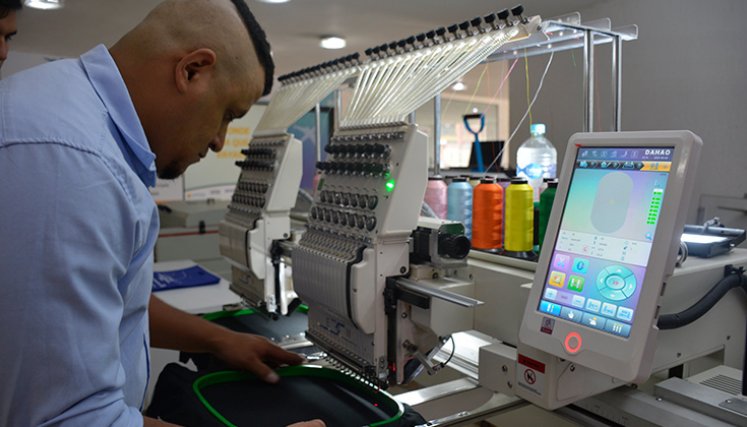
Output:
109,0,274,179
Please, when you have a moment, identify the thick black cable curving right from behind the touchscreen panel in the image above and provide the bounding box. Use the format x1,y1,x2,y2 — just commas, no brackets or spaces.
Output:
657,265,747,330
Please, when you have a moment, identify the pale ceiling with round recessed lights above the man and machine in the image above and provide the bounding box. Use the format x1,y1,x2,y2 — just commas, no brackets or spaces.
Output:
13,0,598,75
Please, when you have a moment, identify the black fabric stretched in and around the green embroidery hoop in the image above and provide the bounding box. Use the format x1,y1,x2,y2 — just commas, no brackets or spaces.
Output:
146,363,425,427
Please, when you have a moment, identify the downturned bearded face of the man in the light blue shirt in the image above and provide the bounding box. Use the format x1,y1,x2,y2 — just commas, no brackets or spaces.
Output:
157,71,264,179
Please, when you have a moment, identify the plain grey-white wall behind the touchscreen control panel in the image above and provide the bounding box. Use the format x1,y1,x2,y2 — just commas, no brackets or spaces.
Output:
511,0,747,221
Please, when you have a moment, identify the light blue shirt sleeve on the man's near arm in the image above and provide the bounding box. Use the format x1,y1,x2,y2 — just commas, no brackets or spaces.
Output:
0,143,143,426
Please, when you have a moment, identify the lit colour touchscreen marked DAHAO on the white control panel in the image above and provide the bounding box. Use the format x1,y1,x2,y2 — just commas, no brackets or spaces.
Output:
538,147,674,337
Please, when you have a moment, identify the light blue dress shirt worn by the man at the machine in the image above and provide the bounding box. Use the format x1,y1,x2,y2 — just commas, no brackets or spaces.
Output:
0,46,158,426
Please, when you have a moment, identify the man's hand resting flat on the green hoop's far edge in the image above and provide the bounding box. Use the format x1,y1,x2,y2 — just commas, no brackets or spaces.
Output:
213,330,306,384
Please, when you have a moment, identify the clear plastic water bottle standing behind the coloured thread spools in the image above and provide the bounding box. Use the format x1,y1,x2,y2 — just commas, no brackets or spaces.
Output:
516,123,558,202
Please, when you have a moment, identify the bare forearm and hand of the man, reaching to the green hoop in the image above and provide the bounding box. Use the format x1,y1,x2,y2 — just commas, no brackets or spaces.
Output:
148,296,304,383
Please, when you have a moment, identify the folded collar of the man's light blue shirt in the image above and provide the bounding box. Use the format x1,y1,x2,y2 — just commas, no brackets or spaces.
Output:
80,45,156,187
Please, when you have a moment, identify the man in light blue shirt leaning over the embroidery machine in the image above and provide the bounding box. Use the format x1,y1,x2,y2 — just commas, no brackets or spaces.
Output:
0,0,322,426
